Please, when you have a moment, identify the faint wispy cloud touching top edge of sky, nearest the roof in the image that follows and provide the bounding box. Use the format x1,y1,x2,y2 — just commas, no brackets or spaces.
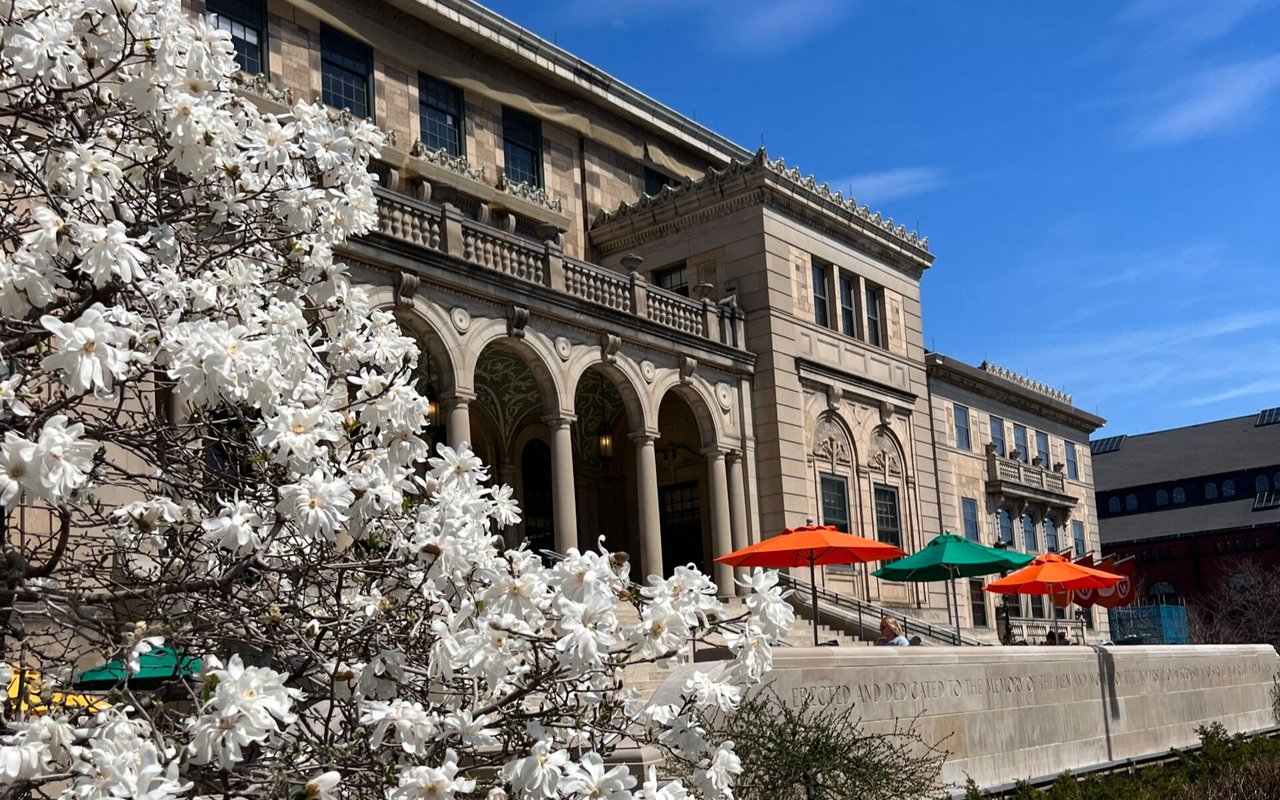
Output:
542,0,856,59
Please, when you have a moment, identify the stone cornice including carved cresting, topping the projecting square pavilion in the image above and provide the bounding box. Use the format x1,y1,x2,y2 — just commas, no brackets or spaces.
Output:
590,148,933,279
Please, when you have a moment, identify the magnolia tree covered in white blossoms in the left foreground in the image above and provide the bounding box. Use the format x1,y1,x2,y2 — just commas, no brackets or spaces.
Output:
0,0,791,800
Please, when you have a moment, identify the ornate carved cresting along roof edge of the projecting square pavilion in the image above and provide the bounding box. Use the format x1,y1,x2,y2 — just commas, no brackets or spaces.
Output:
591,147,929,253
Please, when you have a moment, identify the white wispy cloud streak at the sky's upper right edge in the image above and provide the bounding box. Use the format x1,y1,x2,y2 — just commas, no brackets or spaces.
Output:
1134,55,1280,145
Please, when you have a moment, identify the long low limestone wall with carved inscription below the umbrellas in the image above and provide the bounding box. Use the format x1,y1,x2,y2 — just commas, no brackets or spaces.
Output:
654,645,1280,786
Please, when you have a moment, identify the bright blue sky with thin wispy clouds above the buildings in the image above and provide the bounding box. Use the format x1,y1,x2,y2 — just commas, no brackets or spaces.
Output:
490,0,1280,433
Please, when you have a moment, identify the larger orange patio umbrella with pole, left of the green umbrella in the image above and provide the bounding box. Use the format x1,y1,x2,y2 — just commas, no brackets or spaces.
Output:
716,522,906,645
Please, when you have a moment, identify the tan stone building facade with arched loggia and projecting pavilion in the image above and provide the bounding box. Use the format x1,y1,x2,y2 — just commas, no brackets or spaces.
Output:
188,0,1111,637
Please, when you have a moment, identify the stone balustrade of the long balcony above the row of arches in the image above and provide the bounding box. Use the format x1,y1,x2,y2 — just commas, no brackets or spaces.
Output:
375,187,745,348
